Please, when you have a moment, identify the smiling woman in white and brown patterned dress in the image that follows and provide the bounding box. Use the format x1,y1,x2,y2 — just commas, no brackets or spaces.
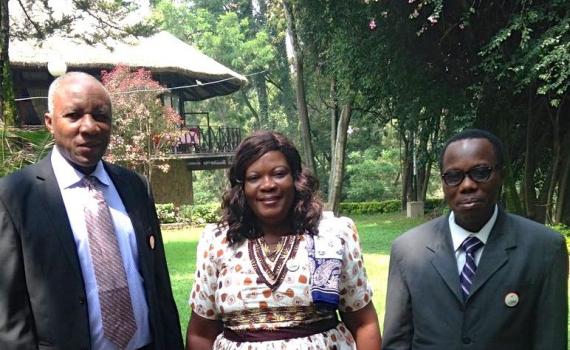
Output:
187,131,381,350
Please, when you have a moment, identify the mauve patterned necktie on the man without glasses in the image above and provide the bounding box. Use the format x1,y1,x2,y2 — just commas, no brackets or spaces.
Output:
83,176,137,349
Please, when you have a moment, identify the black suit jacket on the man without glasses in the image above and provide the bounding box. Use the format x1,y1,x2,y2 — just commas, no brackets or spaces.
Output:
0,156,183,350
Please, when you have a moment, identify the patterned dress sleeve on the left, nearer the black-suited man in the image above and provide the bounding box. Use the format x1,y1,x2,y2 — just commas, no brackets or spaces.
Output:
188,225,219,320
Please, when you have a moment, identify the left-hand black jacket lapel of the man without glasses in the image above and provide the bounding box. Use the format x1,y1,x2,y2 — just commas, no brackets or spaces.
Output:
36,157,83,281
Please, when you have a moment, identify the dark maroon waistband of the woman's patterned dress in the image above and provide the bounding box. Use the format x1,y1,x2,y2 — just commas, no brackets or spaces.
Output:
224,314,338,343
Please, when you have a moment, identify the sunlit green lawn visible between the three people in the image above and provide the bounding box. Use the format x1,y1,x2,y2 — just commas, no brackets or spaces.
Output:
163,214,570,347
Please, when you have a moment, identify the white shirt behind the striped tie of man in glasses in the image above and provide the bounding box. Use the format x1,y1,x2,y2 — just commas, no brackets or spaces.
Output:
449,204,499,275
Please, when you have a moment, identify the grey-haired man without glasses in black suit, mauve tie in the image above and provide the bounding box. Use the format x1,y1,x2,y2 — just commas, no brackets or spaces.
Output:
0,72,183,350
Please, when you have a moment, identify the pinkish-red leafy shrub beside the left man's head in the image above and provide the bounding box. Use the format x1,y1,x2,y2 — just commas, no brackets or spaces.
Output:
101,65,182,180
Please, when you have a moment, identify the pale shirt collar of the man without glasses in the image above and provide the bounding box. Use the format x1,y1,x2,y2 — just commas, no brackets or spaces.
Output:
51,145,111,190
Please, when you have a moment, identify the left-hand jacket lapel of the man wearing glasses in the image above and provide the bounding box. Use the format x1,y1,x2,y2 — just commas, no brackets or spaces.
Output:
426,216,463,303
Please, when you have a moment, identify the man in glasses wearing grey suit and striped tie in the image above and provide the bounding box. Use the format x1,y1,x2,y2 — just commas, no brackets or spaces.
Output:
383,129,568,350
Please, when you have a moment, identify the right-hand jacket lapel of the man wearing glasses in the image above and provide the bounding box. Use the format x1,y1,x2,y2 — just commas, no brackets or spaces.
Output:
470,209,516,296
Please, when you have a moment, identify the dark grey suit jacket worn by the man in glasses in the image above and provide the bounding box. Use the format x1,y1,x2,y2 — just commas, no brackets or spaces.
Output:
382,210,568,350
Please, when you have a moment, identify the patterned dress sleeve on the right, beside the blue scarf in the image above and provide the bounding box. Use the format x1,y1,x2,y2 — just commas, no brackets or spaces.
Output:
338,217,372,312
